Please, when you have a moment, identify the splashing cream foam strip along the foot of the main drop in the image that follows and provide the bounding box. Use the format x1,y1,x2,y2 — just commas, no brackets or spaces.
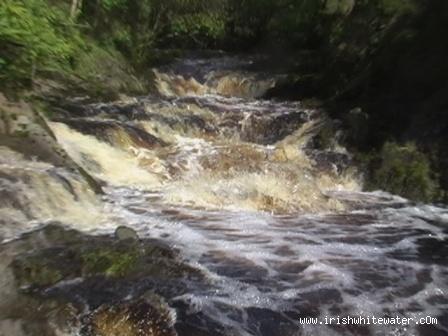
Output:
164,172,343,212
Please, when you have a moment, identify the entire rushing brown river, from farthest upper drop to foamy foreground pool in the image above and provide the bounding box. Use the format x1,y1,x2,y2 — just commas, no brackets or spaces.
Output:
1,58,448,336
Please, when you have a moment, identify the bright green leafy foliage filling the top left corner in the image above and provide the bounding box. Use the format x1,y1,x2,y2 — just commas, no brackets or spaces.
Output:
0,0,82,85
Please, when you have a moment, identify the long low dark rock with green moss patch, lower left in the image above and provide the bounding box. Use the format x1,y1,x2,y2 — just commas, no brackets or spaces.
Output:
11,225,200,289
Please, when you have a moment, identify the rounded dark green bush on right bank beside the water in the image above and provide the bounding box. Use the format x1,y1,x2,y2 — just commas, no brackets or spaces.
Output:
370,142,438,202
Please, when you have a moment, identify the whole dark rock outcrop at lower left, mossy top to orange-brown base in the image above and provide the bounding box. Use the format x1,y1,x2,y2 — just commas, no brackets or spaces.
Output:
0,224,203,336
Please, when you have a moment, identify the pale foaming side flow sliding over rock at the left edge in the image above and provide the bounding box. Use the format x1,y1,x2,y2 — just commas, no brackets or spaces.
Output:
0,147,106,240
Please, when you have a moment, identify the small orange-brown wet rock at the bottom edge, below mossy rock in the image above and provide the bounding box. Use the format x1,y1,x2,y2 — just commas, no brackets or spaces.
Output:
83,300,177,336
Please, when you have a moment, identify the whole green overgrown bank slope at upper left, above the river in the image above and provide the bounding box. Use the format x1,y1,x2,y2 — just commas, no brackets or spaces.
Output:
0,0,149,99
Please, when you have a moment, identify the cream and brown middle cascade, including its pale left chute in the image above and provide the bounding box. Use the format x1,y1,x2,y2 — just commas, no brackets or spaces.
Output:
50,96,360,213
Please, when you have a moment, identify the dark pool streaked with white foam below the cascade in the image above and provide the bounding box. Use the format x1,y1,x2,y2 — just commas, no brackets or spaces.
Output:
102,189,448,336
